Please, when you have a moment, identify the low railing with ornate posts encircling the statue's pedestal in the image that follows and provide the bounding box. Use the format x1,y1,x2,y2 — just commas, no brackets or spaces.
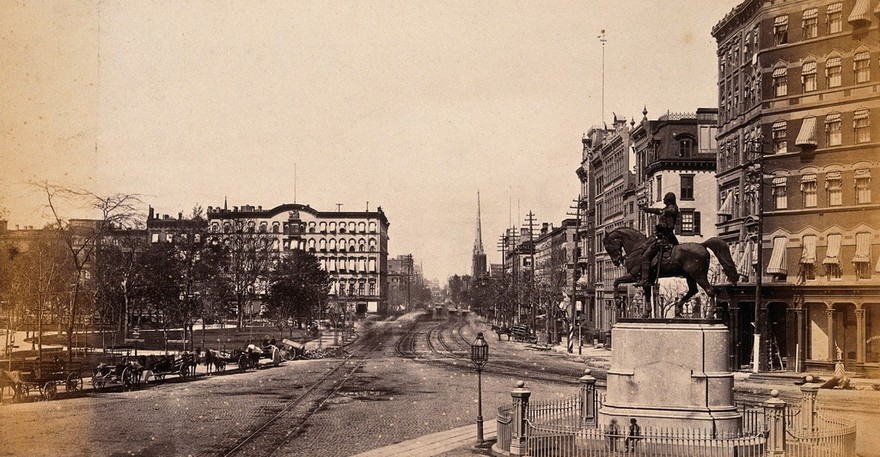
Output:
496,372,856,457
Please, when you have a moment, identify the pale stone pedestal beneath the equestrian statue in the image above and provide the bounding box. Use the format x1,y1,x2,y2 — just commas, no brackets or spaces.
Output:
599,319,740,434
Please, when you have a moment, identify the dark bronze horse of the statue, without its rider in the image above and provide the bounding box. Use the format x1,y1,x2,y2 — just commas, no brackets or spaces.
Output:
602,227,740,318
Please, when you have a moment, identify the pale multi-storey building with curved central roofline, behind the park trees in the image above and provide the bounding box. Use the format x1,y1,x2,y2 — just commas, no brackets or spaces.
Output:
207,203,388,314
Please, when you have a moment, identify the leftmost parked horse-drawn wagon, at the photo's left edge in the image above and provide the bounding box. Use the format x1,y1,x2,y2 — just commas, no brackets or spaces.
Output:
0,356,83,401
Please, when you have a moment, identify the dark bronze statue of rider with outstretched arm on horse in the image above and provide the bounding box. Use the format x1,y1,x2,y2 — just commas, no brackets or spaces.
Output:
603,192,739,318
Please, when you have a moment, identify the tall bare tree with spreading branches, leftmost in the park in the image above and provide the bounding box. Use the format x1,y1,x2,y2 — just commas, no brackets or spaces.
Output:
33,181,141,359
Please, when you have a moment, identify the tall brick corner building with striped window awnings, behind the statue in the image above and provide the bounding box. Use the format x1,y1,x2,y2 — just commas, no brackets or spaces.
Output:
712,0,880,373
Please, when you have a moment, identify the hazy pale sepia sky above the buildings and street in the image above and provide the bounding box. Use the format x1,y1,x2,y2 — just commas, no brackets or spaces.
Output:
0,0,738,281
